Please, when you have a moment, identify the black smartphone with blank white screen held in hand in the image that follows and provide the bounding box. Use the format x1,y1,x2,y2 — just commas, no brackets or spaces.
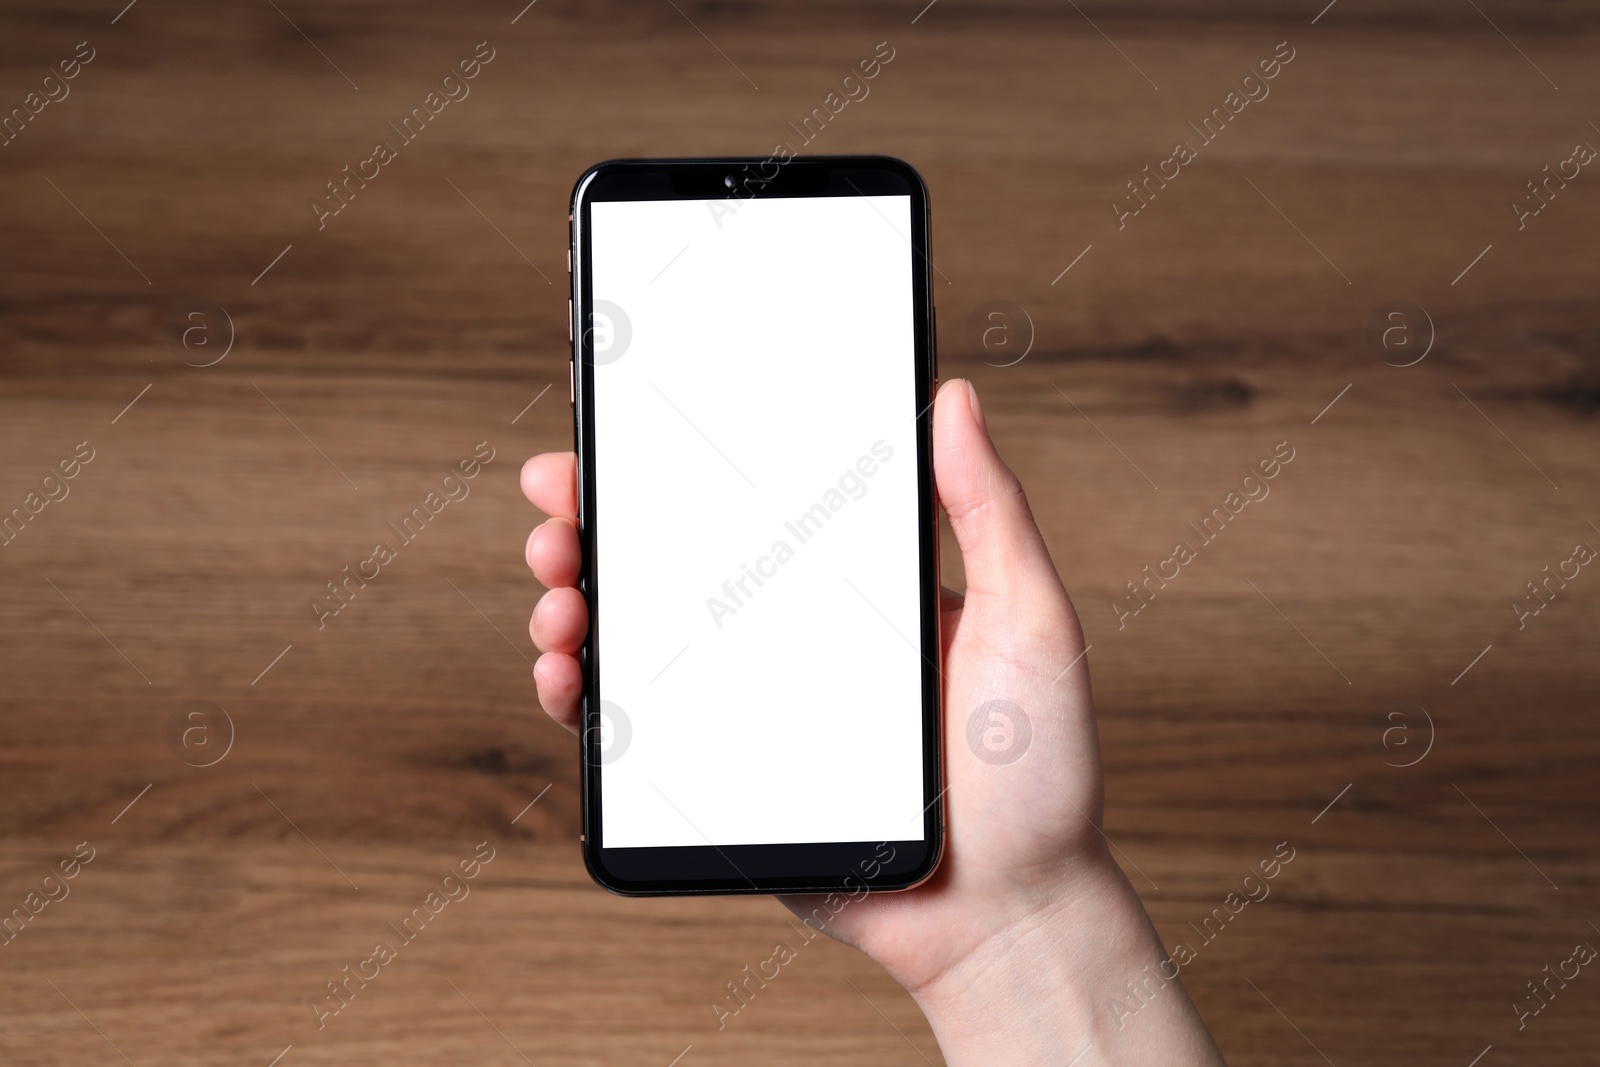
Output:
571,157,944,896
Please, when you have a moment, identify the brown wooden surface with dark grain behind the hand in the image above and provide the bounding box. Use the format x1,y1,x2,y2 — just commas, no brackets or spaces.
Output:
0,0,1600,1067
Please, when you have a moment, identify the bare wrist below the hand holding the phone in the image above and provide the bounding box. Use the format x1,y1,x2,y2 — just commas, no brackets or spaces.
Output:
909,849,1222,1067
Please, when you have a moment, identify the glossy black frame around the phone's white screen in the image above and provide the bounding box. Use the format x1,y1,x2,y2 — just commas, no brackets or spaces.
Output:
570,155,944,897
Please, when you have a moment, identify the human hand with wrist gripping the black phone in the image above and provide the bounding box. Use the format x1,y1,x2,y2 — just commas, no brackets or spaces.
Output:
522,379,1222,1067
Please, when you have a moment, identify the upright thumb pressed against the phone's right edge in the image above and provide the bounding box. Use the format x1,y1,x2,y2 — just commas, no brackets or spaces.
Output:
933,378,1066,603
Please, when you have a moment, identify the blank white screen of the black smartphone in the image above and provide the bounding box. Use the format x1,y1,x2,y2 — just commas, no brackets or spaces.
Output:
590,189,923,848
